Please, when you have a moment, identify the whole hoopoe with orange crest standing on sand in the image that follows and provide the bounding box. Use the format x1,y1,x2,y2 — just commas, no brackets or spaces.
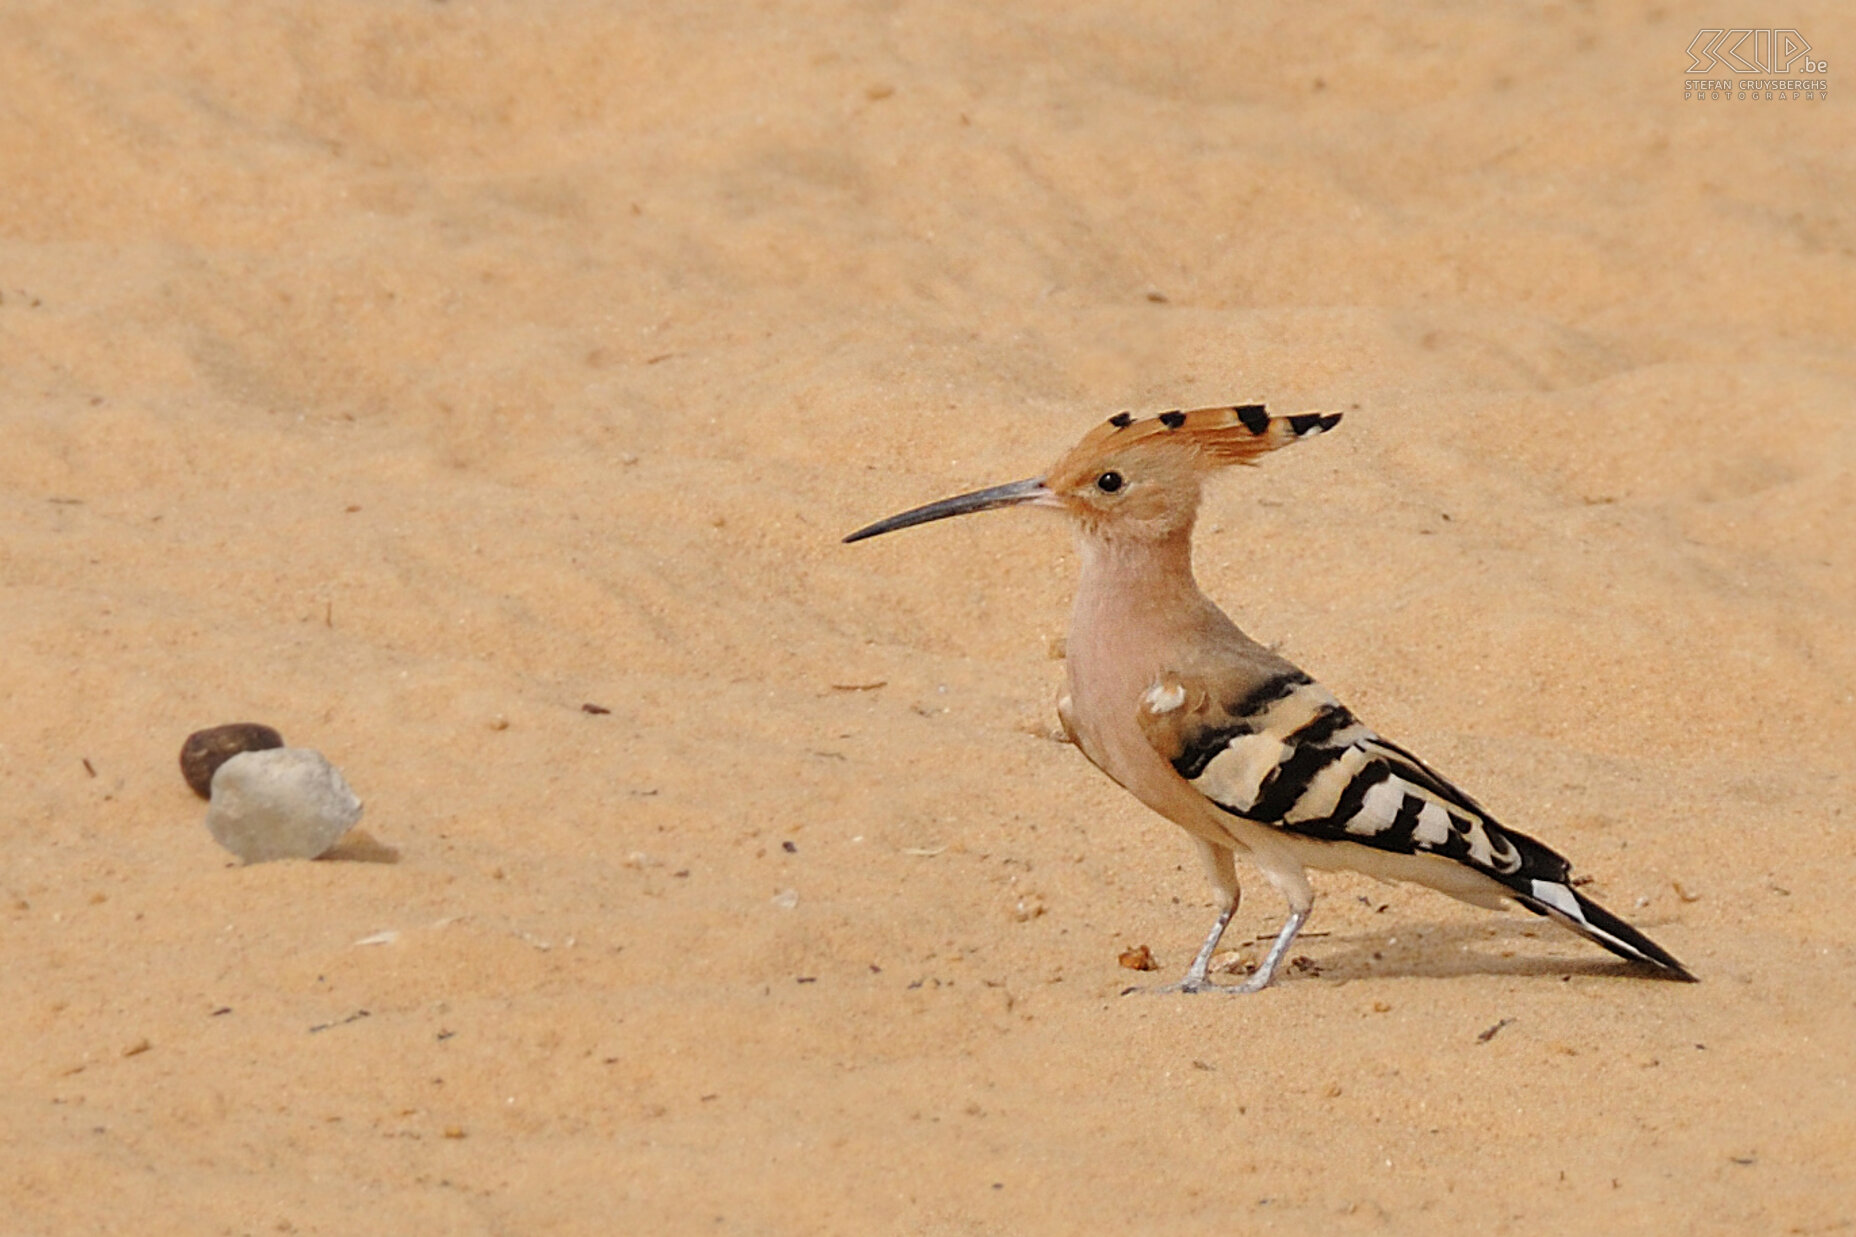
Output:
844,403,1695,994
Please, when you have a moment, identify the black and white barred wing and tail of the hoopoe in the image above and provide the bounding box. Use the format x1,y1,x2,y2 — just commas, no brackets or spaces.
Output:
1141,669,1687,977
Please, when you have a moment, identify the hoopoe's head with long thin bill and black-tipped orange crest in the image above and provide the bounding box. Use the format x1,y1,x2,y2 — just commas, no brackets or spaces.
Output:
844,403,1340,540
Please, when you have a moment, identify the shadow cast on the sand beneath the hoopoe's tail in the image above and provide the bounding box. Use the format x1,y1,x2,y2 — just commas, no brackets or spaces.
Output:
1244,919,1676,983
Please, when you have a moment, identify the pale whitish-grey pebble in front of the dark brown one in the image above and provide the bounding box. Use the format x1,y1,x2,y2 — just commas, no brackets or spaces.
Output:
206,747,362,864
